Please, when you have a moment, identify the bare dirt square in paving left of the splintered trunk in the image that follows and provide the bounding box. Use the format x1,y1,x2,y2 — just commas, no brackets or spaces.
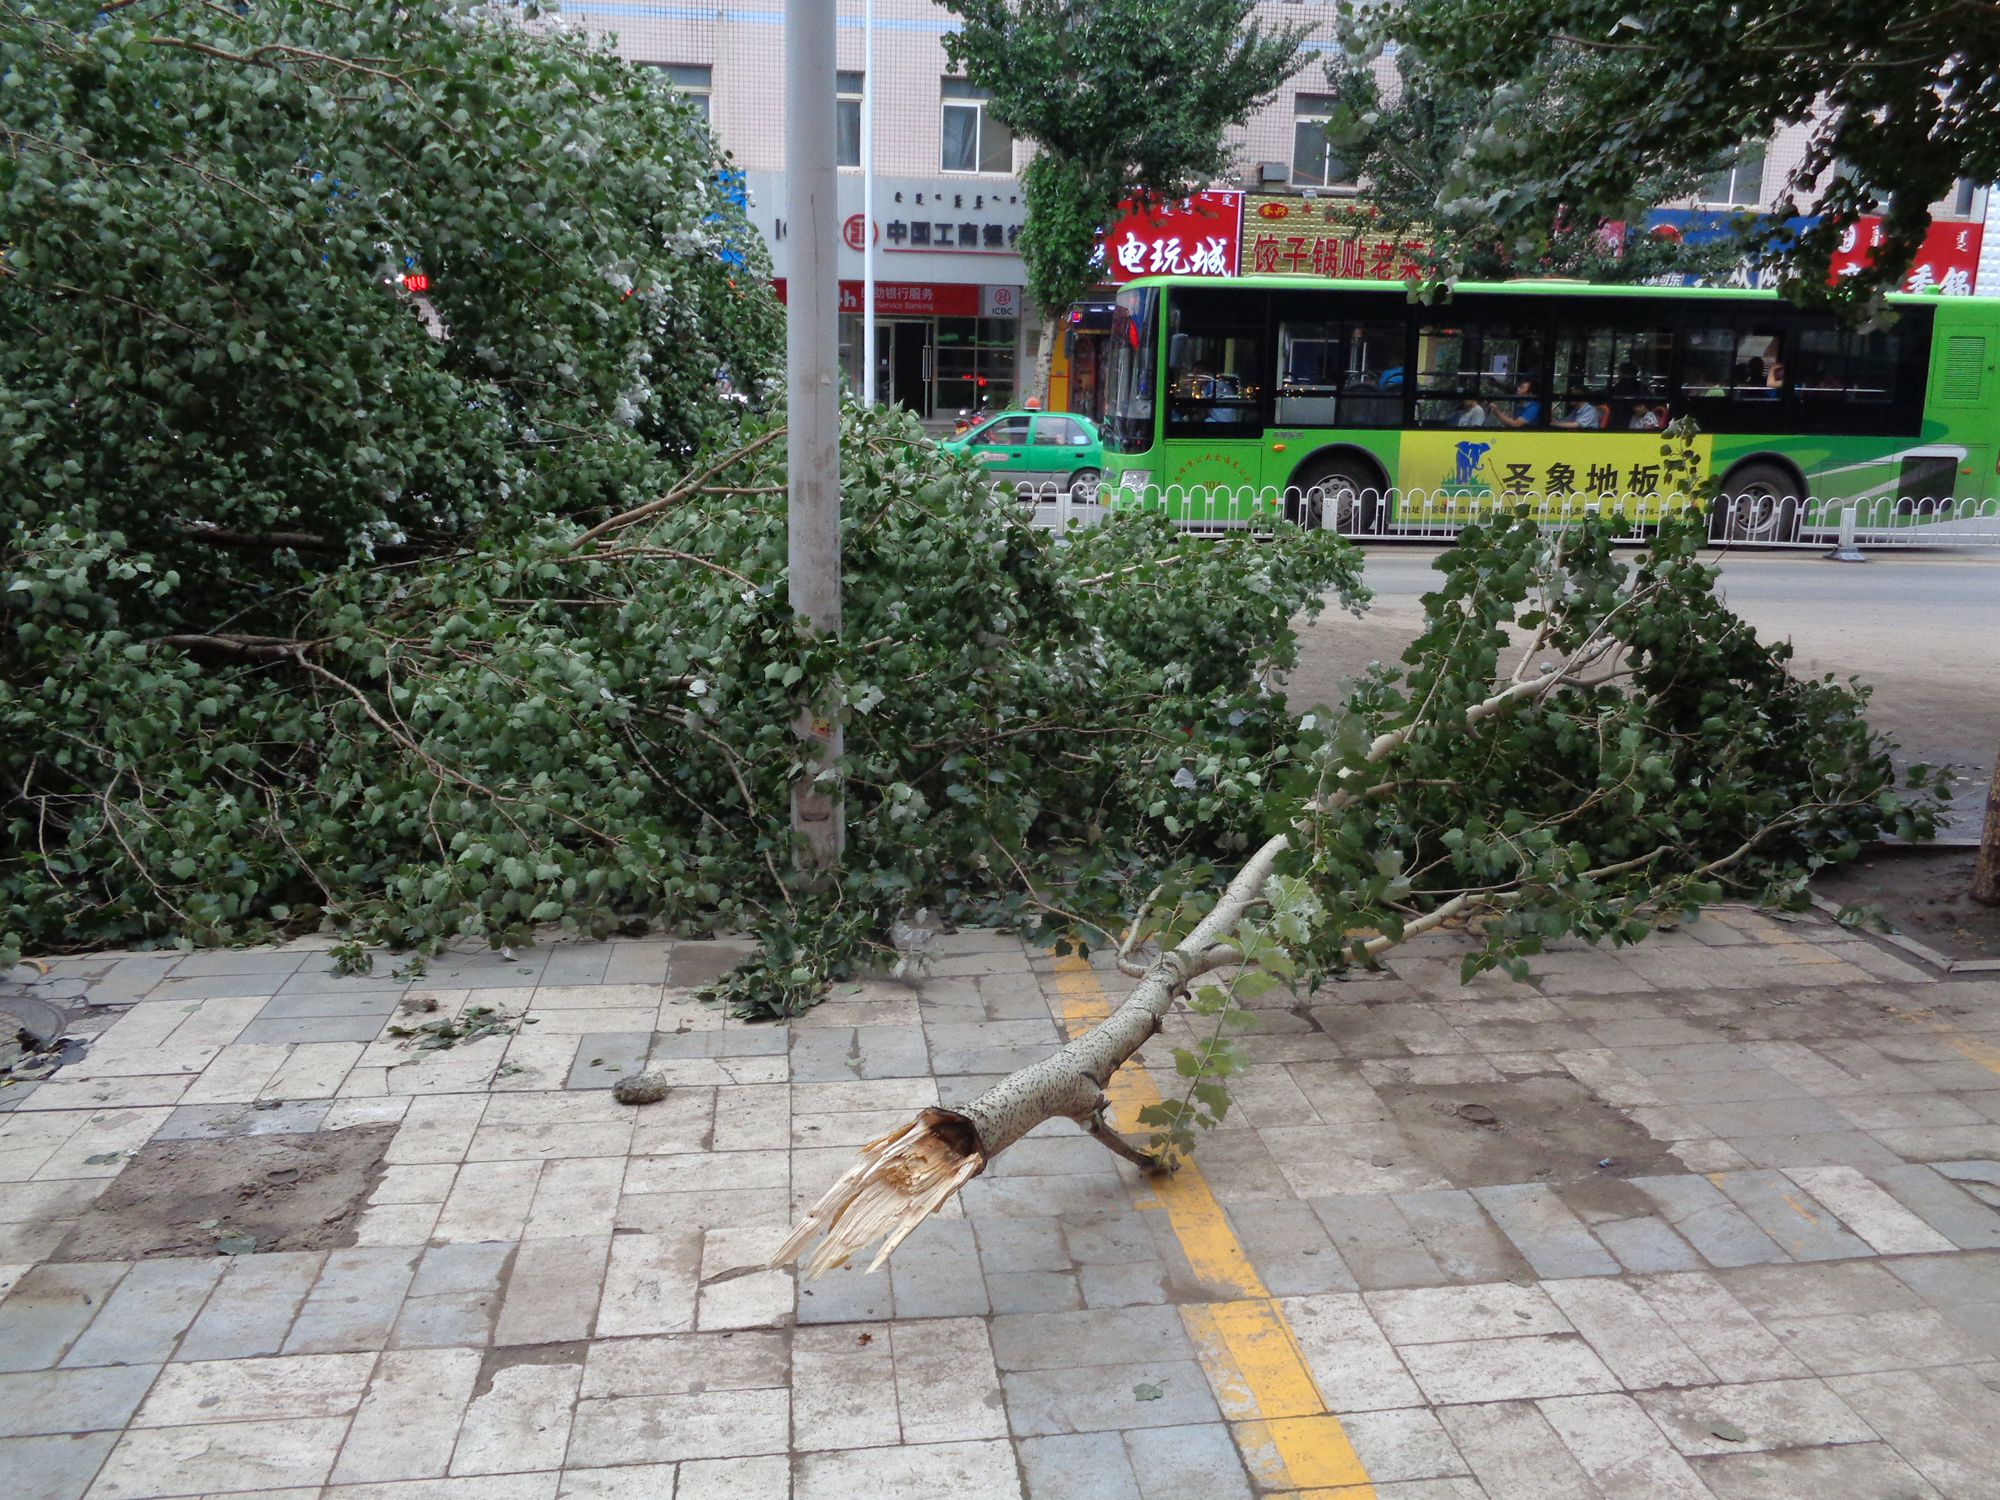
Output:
52,1126,396,1260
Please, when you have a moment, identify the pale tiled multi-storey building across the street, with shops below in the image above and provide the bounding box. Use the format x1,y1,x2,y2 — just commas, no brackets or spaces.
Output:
562,0,2000,422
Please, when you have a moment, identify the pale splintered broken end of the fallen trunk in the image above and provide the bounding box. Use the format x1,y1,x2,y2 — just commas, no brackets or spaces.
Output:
766,1110,986,1276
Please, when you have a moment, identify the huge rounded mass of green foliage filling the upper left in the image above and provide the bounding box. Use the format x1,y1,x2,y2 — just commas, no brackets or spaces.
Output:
0,0,782,632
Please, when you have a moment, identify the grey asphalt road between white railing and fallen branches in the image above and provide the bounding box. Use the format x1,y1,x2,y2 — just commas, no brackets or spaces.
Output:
1288,544,2000,836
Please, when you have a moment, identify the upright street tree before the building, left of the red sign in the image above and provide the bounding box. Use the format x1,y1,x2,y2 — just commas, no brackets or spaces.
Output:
938,0,1310,400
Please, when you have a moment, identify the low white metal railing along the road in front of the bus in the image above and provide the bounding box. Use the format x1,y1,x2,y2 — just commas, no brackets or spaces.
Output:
996,484,2000,550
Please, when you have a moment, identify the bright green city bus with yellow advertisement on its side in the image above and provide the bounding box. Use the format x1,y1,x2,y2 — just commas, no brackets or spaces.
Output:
1100,276,2000,540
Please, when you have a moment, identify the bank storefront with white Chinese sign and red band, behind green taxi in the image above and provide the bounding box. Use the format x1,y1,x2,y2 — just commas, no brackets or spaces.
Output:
750,172,1032,424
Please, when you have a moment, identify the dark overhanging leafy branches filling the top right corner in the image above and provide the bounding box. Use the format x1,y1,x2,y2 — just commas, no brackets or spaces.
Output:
1372,0,2000,302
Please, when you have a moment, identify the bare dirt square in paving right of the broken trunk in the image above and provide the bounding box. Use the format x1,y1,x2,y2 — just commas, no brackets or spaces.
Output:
1376,1074,1682,1188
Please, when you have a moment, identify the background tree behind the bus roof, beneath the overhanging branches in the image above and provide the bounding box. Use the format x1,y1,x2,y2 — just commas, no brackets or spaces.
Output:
1326,46,1738,282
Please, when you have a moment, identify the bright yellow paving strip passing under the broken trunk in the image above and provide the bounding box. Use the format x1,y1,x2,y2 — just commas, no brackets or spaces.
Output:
1056,958,1374,1500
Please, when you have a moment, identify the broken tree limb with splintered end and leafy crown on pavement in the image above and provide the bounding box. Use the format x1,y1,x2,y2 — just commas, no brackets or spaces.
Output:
772,500,1938,1272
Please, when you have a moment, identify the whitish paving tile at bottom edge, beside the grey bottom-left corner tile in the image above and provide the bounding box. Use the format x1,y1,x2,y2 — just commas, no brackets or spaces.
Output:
90,1416,348,1500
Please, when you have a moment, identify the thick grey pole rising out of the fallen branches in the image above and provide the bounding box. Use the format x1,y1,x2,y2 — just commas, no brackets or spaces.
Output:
784,0,846,876
